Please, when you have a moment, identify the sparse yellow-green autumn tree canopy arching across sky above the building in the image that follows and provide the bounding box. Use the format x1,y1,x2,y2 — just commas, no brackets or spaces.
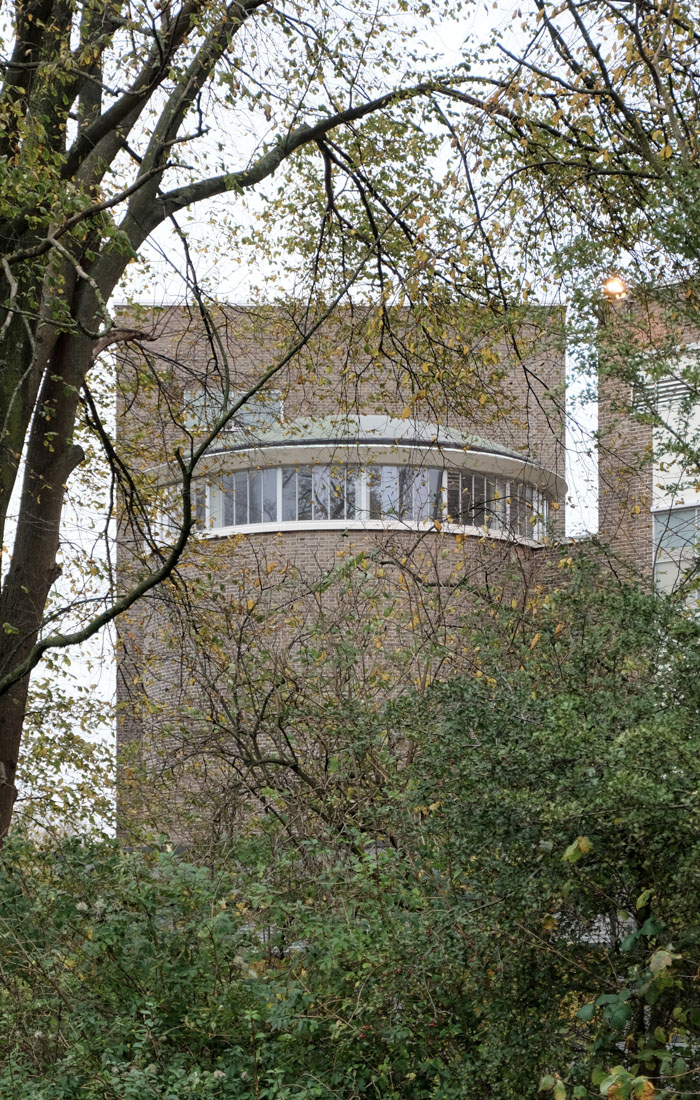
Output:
0,0,698,831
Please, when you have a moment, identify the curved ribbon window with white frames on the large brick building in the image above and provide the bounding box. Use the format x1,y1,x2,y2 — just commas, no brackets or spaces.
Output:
179,464,548,540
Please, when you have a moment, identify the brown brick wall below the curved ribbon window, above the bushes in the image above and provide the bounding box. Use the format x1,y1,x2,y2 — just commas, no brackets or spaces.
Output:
118,530,550,842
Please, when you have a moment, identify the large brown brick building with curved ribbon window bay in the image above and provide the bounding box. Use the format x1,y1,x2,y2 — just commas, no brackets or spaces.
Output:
118,308,566,835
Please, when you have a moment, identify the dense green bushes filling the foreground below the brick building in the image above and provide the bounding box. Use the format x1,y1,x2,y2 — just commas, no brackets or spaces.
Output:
5,559,700,1100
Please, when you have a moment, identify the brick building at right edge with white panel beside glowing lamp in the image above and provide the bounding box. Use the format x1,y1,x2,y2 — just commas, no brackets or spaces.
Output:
599,288,700,593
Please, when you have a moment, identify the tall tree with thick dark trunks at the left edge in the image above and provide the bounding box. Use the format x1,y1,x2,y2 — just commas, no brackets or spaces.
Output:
0,0,475,836
